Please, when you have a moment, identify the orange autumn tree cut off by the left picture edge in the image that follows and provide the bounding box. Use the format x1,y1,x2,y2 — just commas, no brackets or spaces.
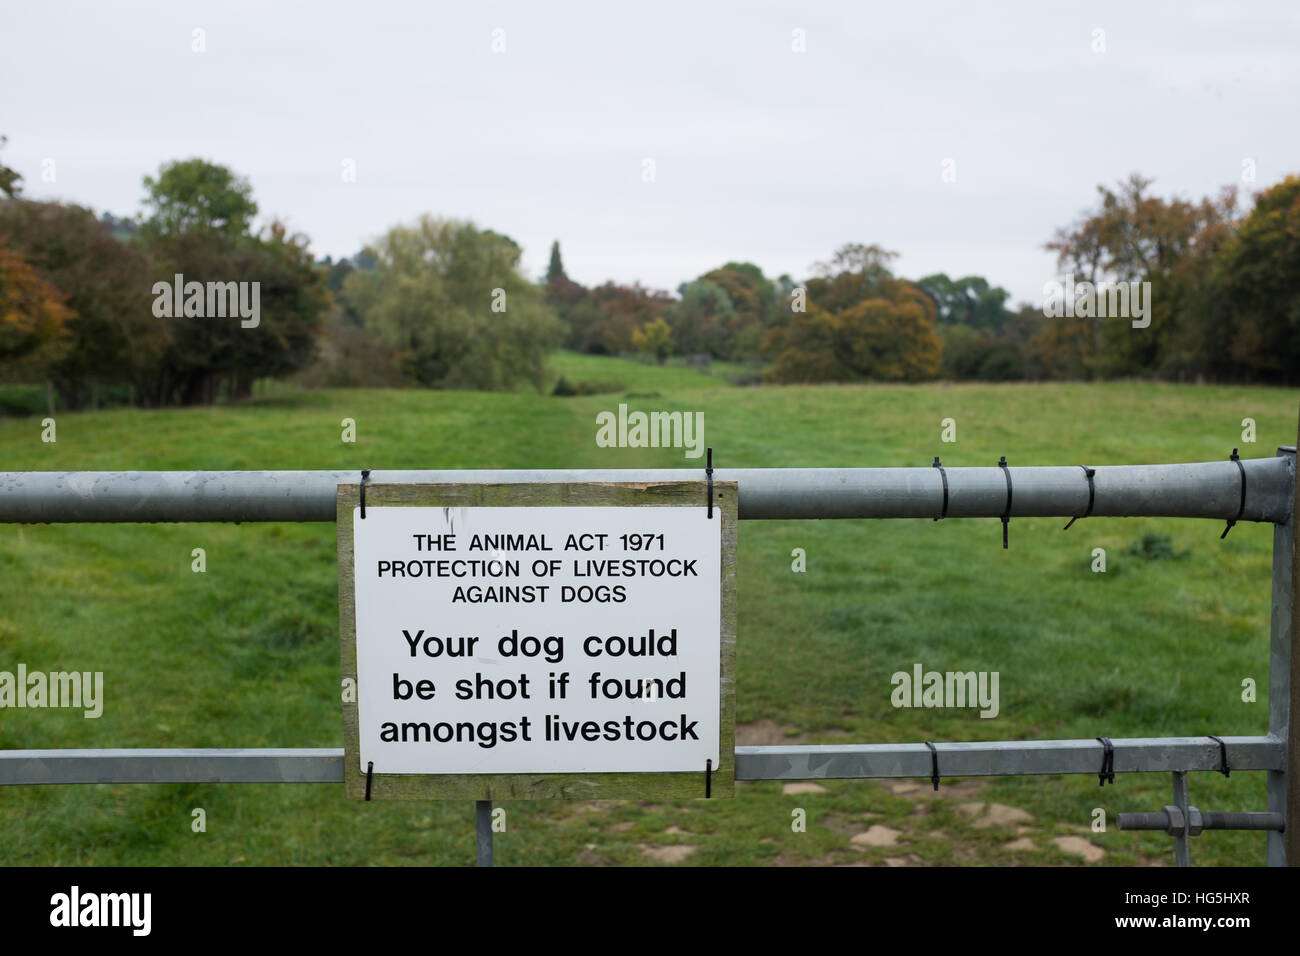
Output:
0,239,70,378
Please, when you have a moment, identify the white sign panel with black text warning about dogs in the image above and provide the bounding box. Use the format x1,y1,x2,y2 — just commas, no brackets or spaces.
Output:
352,505,722,774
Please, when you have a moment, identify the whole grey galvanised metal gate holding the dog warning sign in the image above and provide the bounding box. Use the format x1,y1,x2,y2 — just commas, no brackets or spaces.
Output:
0,446,1300,865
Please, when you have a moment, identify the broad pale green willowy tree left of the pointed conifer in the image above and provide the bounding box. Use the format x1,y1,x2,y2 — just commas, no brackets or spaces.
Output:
343,216,560,389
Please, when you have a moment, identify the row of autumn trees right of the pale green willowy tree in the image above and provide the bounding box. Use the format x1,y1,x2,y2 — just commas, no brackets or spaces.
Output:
546,176,1300,385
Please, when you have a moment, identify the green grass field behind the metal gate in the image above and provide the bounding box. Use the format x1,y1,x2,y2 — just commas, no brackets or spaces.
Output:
0,355,1297,865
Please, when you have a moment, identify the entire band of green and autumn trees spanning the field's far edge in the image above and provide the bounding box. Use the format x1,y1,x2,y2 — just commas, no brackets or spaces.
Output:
0,138,1300,408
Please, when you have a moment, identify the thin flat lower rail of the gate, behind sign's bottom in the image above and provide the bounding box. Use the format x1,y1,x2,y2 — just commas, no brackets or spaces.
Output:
0,736,1284,786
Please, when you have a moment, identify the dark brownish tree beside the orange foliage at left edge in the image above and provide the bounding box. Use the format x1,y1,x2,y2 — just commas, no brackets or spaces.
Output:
0,199,161,408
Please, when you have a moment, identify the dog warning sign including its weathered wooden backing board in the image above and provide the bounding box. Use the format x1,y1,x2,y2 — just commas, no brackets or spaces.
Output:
338,481,736,800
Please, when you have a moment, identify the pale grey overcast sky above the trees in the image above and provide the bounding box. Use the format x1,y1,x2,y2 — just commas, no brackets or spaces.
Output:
0,0,1300,303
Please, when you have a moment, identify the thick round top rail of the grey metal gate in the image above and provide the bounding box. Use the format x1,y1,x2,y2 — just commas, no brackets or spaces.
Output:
0,458,1295,523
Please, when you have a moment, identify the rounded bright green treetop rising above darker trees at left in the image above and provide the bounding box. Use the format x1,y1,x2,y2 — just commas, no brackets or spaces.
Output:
140,159,257,238
